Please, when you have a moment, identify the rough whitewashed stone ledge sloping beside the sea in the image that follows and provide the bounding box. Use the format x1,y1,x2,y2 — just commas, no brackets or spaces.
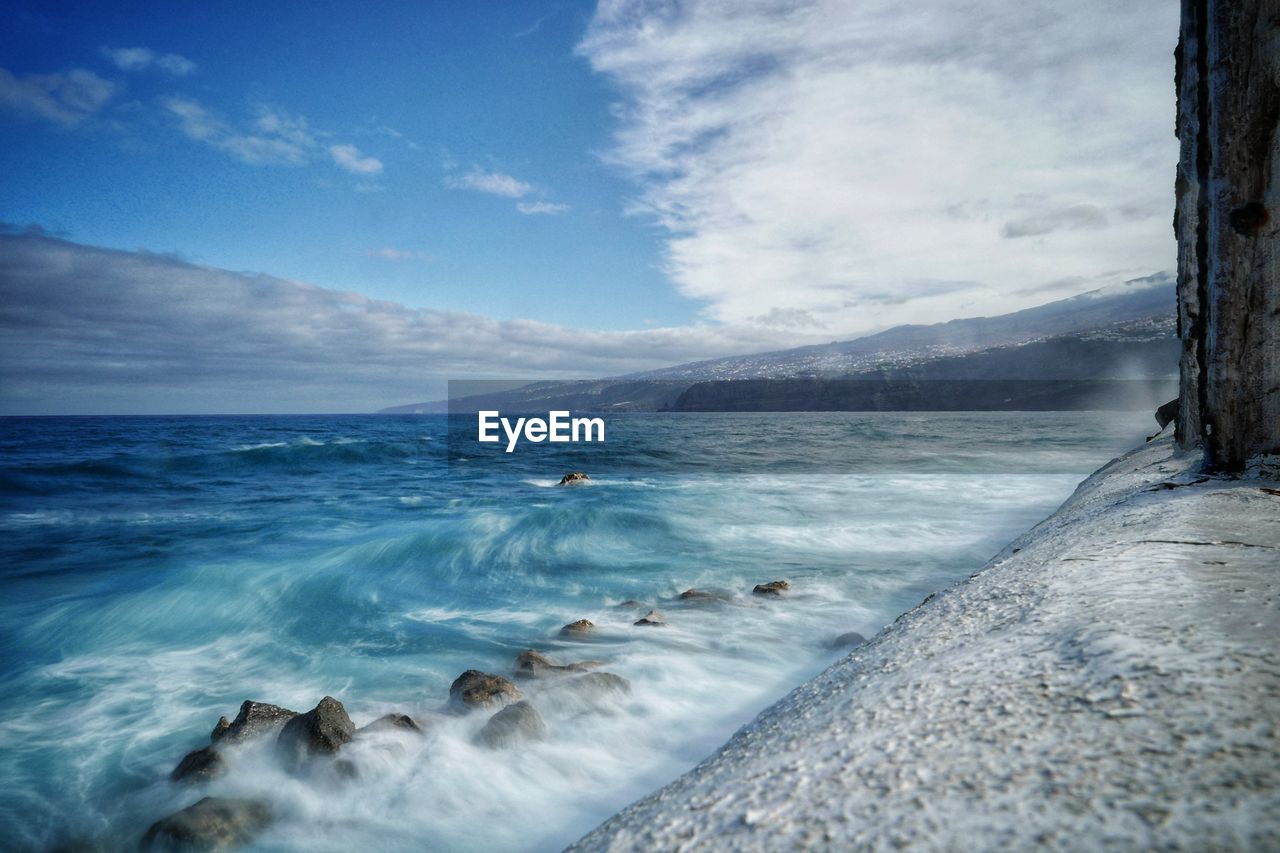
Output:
571,438,1280,850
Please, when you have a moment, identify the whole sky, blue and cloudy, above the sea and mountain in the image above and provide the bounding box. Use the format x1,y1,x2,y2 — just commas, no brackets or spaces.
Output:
0,0,1178,414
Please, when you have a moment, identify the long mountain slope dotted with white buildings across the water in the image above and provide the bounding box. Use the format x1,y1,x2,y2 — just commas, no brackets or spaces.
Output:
381,273,1179,414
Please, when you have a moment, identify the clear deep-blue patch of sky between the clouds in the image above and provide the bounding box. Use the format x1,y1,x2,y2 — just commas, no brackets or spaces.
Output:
0,1,695,329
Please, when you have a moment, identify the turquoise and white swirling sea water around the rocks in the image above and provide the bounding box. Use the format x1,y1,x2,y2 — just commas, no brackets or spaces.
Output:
0,412,1151,850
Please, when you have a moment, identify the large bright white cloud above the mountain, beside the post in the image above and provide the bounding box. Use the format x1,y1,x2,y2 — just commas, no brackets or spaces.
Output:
580,0,1178,337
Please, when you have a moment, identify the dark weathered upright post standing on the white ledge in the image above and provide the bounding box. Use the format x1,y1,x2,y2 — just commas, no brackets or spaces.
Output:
1174,0,1280,470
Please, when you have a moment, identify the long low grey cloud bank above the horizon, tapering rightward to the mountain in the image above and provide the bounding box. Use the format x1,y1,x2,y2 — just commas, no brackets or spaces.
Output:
0,232,795,414
